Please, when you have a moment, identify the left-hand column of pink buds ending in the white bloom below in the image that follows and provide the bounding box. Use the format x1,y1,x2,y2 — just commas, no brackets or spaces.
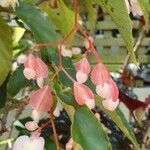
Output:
13,54,53,150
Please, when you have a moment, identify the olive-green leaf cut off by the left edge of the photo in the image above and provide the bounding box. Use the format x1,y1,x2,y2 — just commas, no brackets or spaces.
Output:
0,17,12,86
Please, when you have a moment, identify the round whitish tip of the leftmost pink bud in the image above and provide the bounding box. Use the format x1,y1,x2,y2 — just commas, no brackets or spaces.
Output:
23,68,36,80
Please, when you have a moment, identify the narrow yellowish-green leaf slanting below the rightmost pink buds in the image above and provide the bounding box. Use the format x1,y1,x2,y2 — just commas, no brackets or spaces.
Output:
96,98,138,149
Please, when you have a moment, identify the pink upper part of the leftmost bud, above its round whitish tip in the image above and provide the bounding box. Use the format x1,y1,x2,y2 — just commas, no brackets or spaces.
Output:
24,54,36,70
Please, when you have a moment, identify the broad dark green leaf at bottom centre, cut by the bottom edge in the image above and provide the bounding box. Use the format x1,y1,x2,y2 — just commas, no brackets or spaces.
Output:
72,106,111,150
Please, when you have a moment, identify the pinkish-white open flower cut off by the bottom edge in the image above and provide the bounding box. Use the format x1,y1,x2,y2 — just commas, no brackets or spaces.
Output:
13,135,45,150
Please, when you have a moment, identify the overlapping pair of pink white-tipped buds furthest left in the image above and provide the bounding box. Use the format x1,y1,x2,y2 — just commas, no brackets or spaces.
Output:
23,54,48,88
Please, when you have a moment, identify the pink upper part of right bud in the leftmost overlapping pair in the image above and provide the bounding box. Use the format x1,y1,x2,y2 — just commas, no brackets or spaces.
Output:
36,57,48,78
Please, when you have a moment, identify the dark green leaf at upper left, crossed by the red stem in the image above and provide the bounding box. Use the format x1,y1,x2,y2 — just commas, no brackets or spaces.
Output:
16,3,59,61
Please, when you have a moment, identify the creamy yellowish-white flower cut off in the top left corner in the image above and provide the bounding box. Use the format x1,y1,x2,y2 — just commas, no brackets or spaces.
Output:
0,0,19,10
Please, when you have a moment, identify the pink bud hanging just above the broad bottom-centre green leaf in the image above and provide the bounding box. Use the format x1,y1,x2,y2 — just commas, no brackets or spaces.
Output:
73,82,95,109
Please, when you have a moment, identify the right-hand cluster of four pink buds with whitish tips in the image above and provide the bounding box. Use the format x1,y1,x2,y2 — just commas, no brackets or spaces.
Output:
74,58,119,111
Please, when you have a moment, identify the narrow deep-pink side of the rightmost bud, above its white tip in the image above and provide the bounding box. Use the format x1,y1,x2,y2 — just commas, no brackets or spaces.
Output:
109,79,119,101
